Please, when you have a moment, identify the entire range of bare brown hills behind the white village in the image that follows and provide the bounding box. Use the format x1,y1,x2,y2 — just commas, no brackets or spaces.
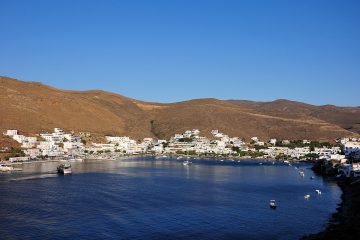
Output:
0,77,360,142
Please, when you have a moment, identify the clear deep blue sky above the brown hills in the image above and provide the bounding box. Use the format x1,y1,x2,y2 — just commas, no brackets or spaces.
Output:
0,0,360,106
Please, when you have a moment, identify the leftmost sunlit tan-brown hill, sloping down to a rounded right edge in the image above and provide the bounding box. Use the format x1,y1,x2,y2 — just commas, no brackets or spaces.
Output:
0,77,150,138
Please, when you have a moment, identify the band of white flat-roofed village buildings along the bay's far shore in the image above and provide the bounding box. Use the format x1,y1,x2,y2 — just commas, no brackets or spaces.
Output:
0,128,360,174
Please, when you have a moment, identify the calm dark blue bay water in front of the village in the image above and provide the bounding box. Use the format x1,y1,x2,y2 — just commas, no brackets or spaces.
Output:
0,158,341,239
